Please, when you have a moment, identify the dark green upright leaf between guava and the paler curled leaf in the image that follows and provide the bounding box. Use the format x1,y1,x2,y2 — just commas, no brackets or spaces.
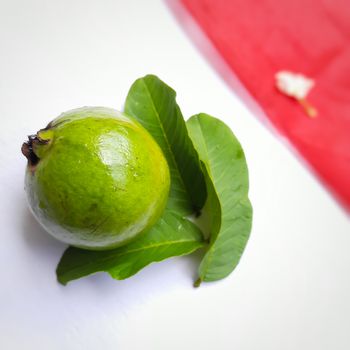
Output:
125,75,206,215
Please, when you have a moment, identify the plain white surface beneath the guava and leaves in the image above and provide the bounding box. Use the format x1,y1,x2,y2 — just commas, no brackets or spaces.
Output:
0,0,350,350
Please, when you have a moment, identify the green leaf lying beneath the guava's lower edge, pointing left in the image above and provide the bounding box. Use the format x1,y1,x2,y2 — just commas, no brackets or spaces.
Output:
56,212,204,285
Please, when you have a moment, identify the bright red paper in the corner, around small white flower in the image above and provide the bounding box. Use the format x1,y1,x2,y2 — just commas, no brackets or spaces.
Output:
181,0,350,210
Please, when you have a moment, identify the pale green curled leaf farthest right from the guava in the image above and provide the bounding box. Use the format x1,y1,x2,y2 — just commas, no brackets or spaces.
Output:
187,114,252,285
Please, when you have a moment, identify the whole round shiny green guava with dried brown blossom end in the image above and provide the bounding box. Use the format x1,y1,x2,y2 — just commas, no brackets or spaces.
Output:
22,107,170,250
